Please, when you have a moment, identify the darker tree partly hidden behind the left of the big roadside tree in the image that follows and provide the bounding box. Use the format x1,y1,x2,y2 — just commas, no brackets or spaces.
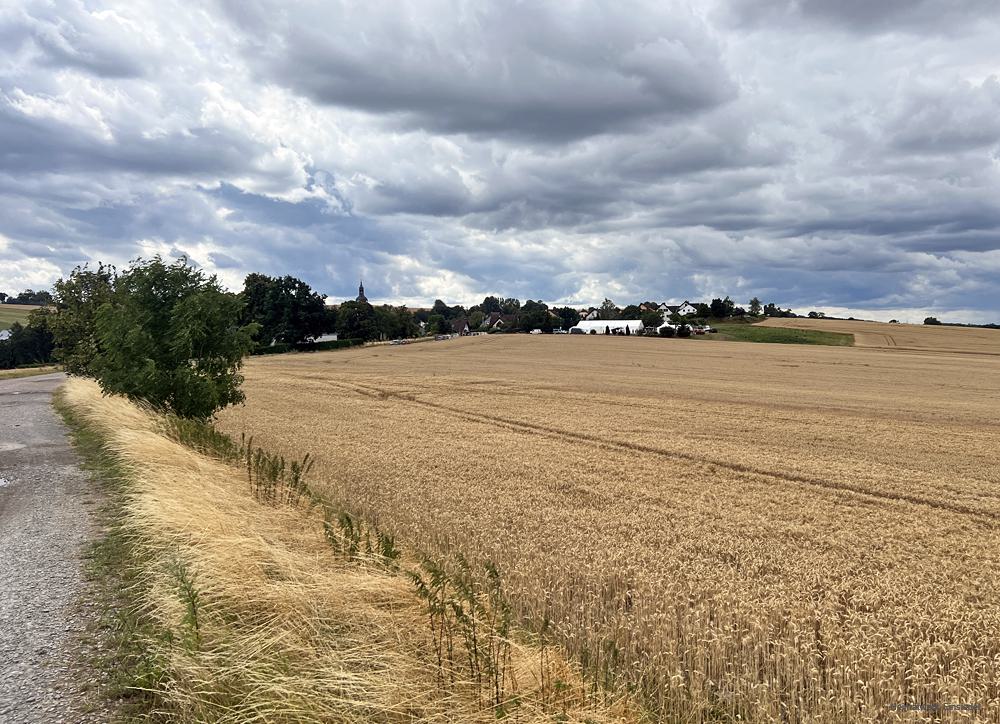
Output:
49,263,116,376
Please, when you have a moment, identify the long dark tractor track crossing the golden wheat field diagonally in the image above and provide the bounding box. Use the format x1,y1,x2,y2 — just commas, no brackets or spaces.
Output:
319,379,1000,527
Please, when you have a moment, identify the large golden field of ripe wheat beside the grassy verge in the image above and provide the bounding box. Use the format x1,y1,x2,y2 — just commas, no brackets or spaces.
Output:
219,332,1000,722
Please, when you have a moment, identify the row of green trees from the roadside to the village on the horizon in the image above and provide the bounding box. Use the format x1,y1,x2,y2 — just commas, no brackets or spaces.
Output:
0,256,820,419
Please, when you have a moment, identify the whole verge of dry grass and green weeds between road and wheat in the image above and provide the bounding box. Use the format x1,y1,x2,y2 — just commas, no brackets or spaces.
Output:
58,379,635,722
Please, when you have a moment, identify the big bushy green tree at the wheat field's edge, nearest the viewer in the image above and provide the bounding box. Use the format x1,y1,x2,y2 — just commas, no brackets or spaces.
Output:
89,256,256,419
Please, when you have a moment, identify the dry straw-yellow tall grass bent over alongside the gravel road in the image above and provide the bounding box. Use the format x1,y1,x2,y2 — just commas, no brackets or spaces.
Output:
64,378,626,723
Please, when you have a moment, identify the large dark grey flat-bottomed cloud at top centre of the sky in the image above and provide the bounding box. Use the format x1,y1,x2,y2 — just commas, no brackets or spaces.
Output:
221,0,735,140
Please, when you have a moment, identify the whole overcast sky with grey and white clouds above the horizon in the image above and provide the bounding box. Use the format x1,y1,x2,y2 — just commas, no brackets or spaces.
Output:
0,0,1000,321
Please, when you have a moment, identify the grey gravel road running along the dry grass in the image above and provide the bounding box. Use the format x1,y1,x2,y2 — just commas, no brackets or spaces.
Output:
0,374,107,724
